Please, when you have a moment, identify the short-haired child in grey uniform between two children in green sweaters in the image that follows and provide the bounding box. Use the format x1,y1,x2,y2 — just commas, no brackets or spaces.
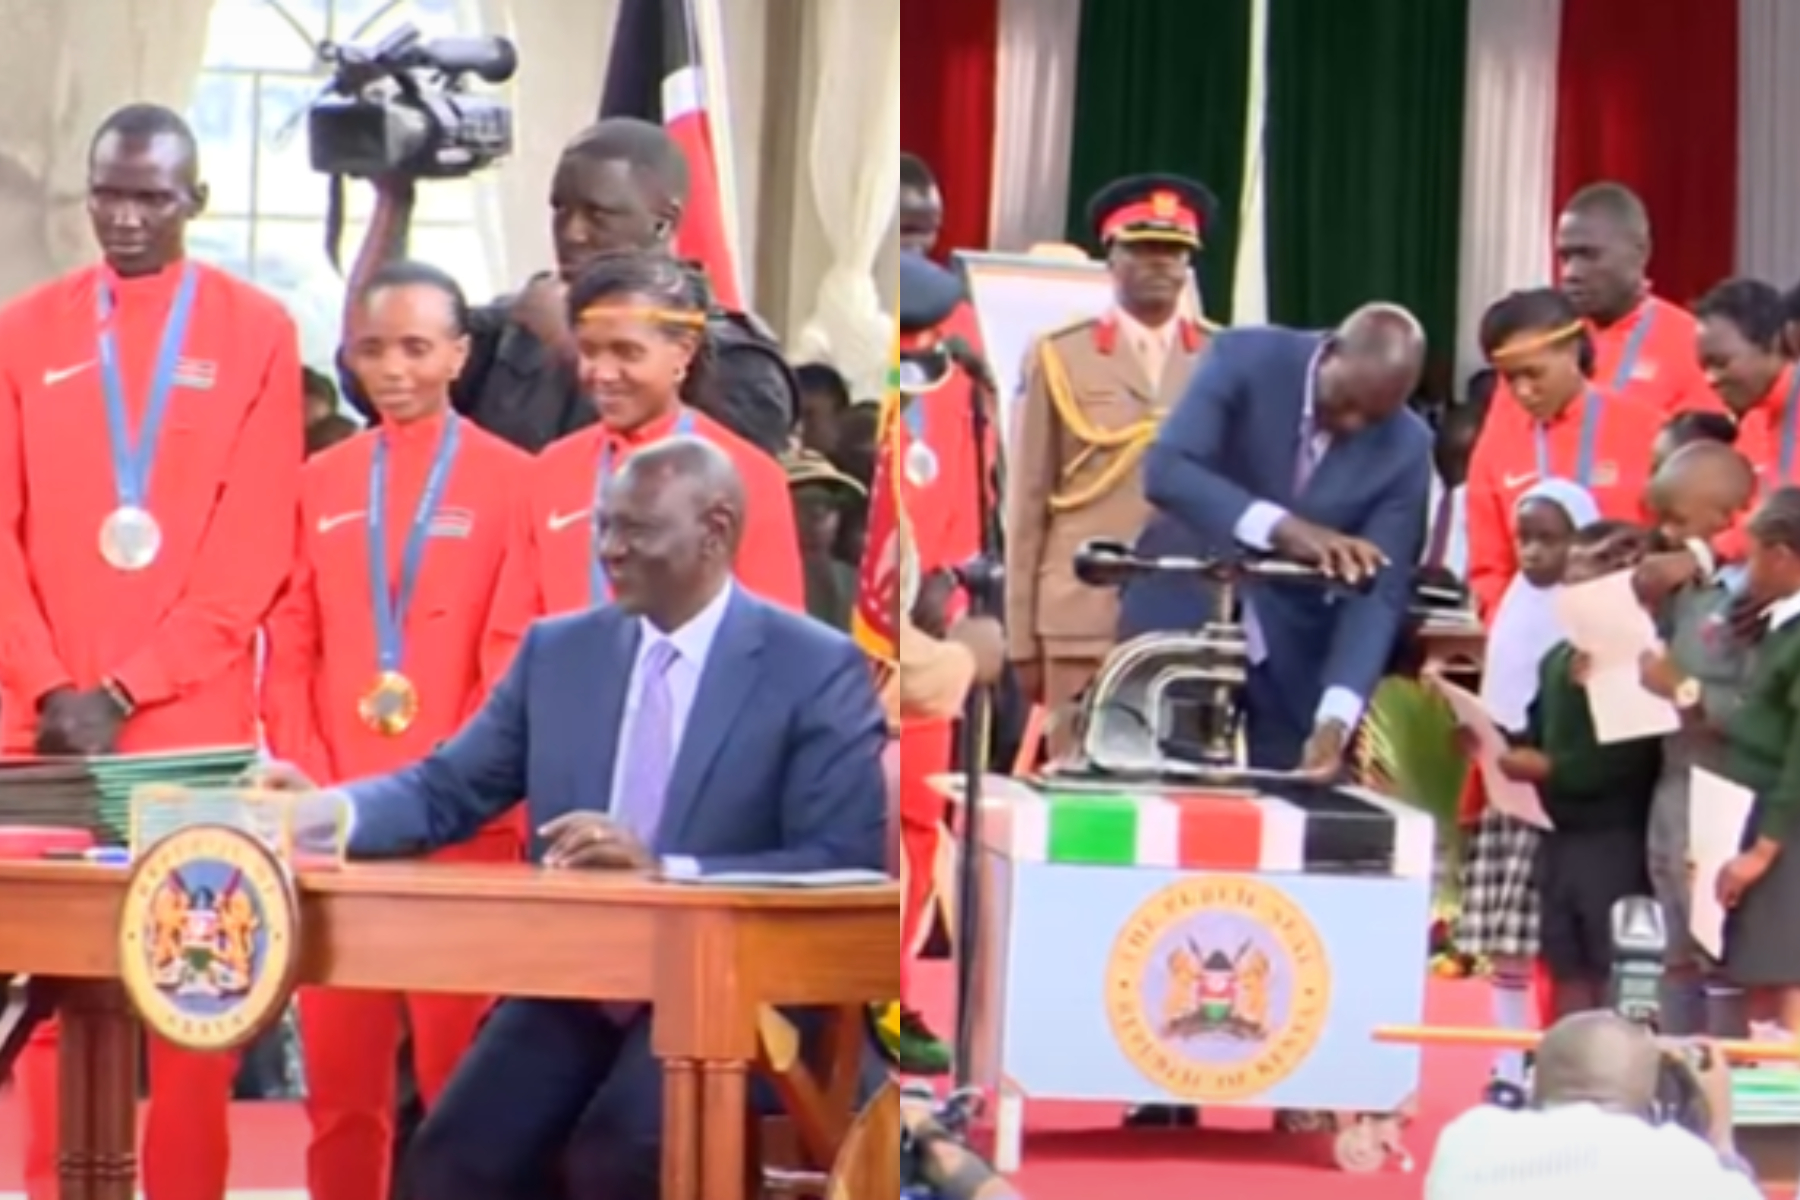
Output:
1642,440,1757,1036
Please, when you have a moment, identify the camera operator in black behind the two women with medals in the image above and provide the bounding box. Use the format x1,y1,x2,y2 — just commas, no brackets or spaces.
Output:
342,117,799,453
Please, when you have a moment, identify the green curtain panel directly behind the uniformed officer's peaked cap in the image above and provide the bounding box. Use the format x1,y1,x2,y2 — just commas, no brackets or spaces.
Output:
1069,0,1252,322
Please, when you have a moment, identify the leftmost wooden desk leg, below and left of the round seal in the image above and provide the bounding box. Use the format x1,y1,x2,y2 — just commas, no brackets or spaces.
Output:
59,982,137,1200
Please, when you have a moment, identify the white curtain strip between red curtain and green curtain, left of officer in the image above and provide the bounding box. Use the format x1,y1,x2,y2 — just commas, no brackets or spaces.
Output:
988,0,1080,252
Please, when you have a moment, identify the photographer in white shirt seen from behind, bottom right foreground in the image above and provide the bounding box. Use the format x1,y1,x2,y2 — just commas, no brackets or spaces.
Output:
1426,1009,1762,1200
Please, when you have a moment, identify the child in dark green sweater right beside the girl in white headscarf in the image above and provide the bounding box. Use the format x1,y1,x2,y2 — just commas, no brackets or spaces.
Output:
1499,520,1661,1018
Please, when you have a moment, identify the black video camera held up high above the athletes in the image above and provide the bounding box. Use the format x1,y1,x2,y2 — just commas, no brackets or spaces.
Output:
306,25,518,180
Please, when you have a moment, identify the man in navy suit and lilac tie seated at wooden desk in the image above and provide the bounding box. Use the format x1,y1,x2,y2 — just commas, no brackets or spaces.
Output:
257,437,898,1200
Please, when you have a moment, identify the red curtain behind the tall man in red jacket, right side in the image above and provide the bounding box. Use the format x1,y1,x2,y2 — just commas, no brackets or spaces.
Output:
1557,0,1737,304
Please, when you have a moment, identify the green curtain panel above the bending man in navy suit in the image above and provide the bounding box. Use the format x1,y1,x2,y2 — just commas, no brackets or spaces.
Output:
1260,0,1469,360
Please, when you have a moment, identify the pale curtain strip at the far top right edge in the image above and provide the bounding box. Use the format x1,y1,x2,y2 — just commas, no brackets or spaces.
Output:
1737,0,1800,288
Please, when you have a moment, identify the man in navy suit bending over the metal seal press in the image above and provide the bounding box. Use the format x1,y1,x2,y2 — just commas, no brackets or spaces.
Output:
1145,304,1431,775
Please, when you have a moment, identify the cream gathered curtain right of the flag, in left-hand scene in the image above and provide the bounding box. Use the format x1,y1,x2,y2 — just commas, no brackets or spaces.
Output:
794,0,900,396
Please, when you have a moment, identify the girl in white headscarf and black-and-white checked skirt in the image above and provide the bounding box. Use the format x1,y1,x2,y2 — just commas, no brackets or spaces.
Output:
1456,479,1600,1088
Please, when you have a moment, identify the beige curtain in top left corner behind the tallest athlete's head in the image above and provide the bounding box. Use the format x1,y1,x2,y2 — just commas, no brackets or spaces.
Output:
0,0,212,297
